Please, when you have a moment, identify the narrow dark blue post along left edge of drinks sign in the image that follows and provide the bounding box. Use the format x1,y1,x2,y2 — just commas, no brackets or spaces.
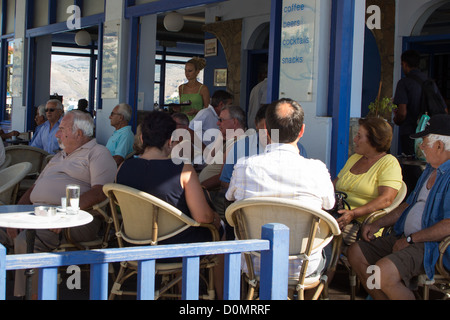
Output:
267,0,283,102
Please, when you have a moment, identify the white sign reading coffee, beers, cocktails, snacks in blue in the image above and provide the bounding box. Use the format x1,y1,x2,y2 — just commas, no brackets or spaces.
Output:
280,0,316,101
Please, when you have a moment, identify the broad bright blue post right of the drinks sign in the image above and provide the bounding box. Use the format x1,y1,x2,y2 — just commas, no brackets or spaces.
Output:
329,0,356,178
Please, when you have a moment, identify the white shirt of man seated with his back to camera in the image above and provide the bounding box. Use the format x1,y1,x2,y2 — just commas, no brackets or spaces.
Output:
225,144,335,278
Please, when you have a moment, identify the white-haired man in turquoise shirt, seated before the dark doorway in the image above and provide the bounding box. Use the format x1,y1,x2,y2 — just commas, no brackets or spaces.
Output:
106,103,134,166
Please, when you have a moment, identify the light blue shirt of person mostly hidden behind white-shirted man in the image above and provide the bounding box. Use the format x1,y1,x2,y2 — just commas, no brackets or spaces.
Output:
220,133,308,183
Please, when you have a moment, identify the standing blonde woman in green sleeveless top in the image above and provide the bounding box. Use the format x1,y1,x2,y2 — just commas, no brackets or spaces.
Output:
178,57,210,120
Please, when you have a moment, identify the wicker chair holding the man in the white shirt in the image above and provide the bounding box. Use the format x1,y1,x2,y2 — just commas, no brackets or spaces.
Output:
225,197,340,300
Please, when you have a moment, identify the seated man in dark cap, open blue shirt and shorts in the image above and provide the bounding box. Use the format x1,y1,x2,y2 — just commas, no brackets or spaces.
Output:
348,114,450,300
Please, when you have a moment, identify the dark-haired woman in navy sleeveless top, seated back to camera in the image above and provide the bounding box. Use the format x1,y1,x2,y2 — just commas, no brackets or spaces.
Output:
117,111,221,244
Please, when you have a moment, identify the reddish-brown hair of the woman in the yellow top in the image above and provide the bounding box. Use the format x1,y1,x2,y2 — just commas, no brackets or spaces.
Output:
358,117,392,152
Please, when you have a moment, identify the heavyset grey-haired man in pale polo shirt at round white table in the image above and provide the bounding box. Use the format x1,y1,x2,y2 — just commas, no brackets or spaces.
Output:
8,110,117,296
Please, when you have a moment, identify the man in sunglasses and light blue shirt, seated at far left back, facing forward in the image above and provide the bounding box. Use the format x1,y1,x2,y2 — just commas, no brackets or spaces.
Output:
30,99,64,154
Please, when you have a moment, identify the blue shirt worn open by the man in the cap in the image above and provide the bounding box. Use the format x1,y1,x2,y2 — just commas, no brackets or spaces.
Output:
394,160,450,279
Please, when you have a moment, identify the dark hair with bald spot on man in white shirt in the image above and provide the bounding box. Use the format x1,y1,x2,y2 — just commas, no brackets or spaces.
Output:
266,99,305,143
